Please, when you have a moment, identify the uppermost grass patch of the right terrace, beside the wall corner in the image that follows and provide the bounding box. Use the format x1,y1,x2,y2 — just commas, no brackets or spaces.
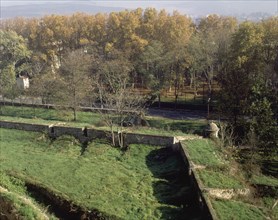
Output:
183,139,227,166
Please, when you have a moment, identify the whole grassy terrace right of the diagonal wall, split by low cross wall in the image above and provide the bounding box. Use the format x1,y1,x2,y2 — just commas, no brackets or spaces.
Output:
183,139,278,220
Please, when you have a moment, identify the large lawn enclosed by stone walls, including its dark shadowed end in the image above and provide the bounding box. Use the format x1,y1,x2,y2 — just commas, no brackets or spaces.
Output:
0,129,195,219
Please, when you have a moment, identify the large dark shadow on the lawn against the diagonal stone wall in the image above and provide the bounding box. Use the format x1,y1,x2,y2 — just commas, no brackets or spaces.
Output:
146,148,203,219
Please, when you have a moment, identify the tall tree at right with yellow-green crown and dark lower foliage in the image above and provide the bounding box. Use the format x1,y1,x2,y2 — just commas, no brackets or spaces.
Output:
219,22,264,126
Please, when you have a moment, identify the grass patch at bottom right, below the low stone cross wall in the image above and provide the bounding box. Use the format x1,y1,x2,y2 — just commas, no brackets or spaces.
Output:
212,200,266,220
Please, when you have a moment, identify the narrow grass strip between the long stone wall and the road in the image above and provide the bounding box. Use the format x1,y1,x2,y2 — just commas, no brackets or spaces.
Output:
1,106,206,135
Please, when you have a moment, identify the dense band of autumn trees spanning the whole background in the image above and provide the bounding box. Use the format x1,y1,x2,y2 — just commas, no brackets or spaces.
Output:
0,8,278,156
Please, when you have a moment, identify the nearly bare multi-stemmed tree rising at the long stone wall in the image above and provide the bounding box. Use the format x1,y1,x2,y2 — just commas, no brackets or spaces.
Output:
91,52,146,147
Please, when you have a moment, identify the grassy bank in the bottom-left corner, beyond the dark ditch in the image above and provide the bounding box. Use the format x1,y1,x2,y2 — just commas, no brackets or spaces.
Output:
0,171,57,220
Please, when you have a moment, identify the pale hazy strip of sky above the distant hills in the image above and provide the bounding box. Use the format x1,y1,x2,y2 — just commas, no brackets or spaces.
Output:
0,0,278,15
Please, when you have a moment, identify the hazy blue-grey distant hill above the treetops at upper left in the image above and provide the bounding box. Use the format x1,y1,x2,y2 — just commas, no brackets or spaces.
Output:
0,2,125,19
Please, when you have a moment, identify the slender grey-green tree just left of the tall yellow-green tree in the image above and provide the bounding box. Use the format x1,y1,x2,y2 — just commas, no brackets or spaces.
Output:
197,15,237,98
